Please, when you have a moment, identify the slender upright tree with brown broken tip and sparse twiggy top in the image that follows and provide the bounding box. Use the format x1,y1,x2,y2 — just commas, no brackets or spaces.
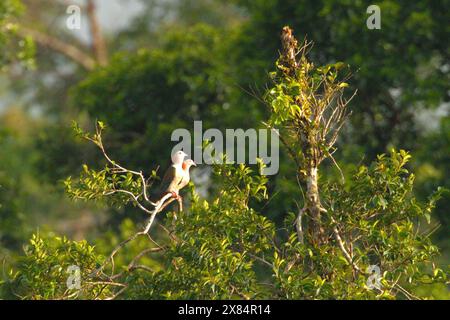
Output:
266,27,353,244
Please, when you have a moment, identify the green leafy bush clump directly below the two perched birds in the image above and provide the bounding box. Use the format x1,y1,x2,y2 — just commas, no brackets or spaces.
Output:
125,165,275,299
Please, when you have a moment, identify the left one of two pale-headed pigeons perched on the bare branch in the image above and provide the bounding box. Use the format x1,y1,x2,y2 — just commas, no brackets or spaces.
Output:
160,151,187,198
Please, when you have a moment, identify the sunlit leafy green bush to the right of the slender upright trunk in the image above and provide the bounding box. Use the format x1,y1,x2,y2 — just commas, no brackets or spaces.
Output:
274,151,448,299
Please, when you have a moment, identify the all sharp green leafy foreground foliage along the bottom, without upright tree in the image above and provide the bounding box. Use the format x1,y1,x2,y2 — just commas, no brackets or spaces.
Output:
2,120,448,299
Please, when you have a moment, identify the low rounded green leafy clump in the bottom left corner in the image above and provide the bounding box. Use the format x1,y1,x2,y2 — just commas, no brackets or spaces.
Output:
1,234,109,300
